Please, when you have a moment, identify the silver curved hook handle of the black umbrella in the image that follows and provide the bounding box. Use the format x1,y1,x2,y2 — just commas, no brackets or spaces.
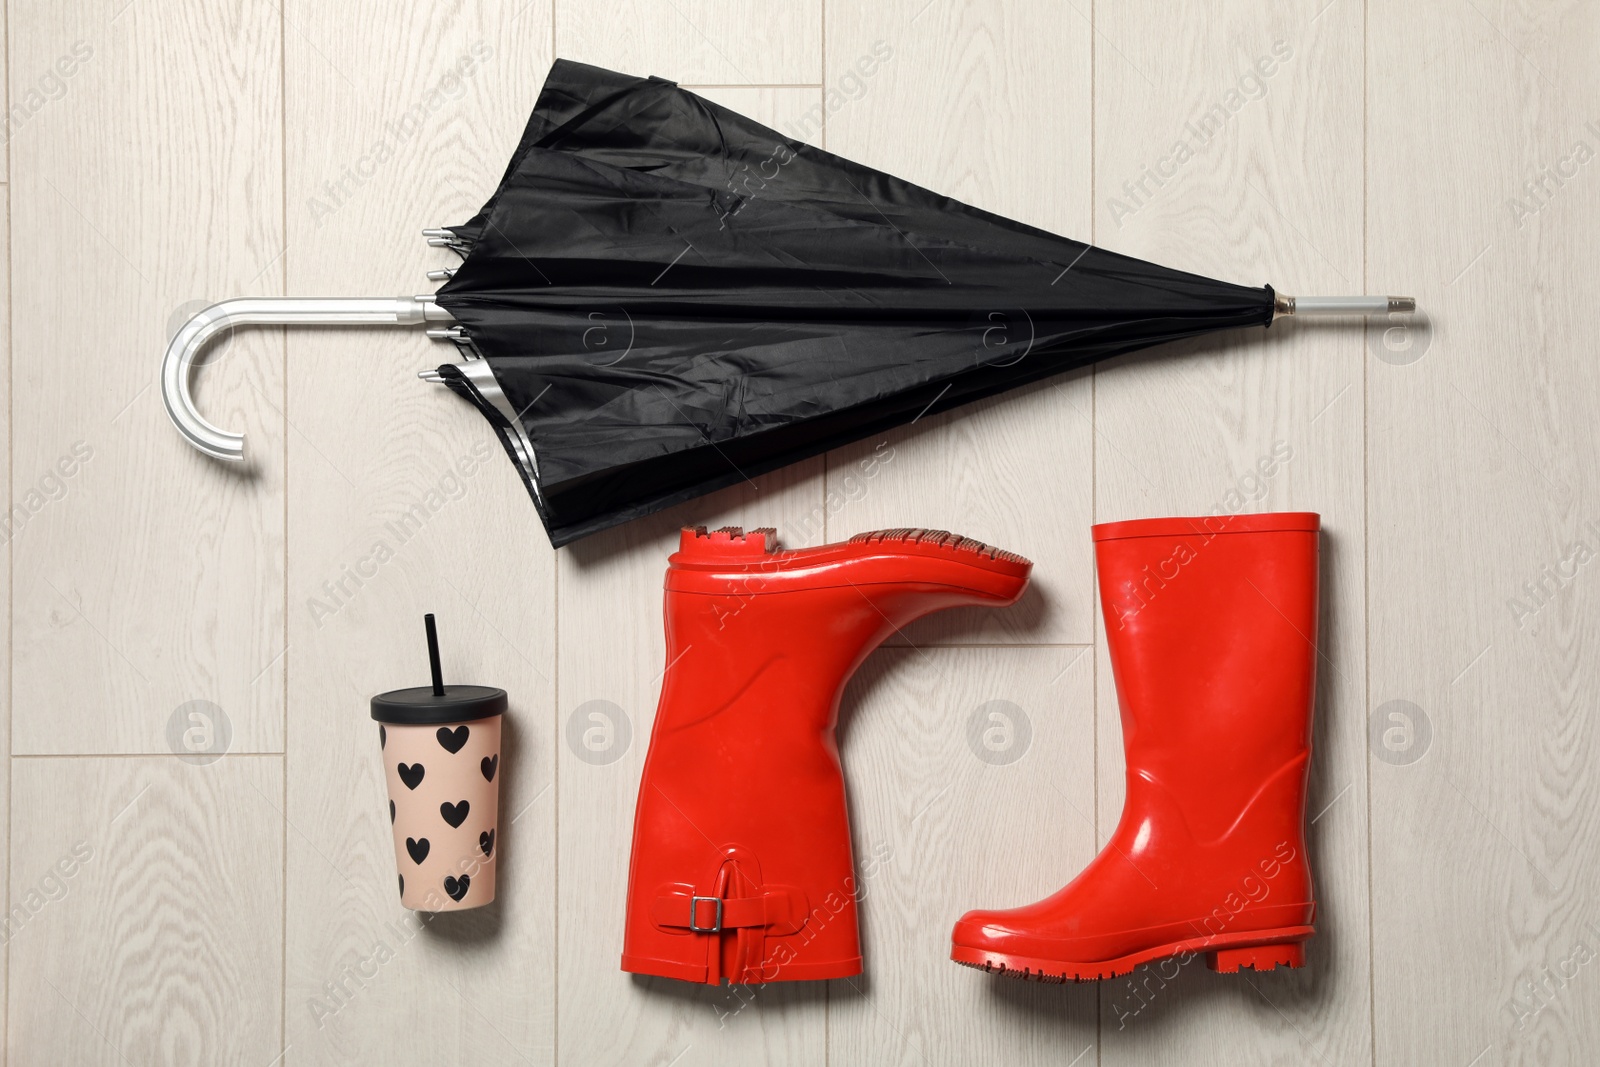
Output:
162,293,454,461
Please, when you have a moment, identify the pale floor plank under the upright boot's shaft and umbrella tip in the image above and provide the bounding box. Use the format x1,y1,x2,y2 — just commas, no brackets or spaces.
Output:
1094,2,1371,1064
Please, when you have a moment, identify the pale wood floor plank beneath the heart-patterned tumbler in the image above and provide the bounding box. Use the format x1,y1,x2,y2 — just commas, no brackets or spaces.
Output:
285,2,555,1064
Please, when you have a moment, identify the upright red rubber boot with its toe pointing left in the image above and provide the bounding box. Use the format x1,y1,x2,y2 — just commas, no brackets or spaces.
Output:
950,512,1320,981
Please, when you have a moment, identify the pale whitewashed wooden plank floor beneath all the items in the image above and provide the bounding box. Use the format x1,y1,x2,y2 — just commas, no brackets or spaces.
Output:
0,0,1600,1067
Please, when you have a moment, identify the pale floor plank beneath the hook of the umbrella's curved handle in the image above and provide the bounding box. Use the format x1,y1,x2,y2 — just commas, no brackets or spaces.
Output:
10,0,283,753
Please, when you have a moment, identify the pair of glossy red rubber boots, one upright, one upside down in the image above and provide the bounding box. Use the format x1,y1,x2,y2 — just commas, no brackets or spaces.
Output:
622,512,1320,984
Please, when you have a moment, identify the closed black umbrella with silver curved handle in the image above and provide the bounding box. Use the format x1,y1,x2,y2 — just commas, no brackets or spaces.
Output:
163,62,1411,545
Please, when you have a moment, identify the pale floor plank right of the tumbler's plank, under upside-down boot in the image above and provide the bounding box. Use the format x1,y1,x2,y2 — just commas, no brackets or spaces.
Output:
557,86,826,1064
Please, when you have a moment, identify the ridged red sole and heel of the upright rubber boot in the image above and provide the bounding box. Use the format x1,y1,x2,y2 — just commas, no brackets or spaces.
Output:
950,926,1315,984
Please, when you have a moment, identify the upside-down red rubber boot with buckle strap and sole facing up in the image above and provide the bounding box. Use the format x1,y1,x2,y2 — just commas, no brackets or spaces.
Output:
622,530,1032,984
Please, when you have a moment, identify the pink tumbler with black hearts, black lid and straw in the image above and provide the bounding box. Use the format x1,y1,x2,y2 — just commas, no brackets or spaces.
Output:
373,614,506,912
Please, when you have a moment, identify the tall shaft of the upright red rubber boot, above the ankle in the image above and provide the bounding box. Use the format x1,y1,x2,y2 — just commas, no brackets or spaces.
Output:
1094,512,1320,837
